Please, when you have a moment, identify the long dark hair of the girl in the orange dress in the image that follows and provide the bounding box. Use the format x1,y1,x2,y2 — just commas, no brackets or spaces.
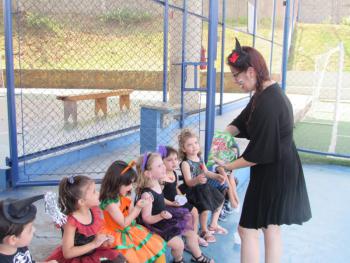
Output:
100,161,136,201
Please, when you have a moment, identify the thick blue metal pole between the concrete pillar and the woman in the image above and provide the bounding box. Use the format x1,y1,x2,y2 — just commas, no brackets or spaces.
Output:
204,1,218,161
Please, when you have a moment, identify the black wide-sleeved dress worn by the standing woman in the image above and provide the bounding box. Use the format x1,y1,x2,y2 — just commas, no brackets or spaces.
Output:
231,83,311,229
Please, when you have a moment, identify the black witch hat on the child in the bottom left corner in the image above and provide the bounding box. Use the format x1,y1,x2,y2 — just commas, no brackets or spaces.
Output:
2,195,44,224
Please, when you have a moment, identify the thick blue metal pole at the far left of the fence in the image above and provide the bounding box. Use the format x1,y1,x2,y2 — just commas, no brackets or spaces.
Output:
3,0,19,185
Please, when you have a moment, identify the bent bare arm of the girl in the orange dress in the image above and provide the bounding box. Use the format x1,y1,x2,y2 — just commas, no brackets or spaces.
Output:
106,199,147,228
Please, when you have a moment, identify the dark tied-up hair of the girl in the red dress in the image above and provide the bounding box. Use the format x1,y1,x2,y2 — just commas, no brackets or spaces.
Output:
58,175,93,215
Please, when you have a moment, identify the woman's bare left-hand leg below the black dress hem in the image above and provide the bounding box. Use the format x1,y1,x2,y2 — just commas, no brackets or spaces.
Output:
238,226,259,263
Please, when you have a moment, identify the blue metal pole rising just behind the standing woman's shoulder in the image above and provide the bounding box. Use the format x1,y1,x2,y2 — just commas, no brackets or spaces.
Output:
282,0,290,91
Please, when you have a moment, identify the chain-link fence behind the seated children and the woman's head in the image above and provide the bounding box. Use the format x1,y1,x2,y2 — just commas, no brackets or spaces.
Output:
2,0,290,185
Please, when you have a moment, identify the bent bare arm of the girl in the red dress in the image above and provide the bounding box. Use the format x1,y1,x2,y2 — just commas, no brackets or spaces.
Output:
62,223,108,259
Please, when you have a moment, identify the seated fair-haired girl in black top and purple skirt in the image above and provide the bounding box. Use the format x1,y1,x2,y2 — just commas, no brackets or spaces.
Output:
137,153,214,263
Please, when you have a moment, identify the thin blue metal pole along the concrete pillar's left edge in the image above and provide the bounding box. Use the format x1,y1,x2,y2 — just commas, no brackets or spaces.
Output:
163,0,169,102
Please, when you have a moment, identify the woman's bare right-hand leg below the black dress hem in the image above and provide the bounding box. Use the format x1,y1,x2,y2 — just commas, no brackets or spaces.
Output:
262,225,282,263
